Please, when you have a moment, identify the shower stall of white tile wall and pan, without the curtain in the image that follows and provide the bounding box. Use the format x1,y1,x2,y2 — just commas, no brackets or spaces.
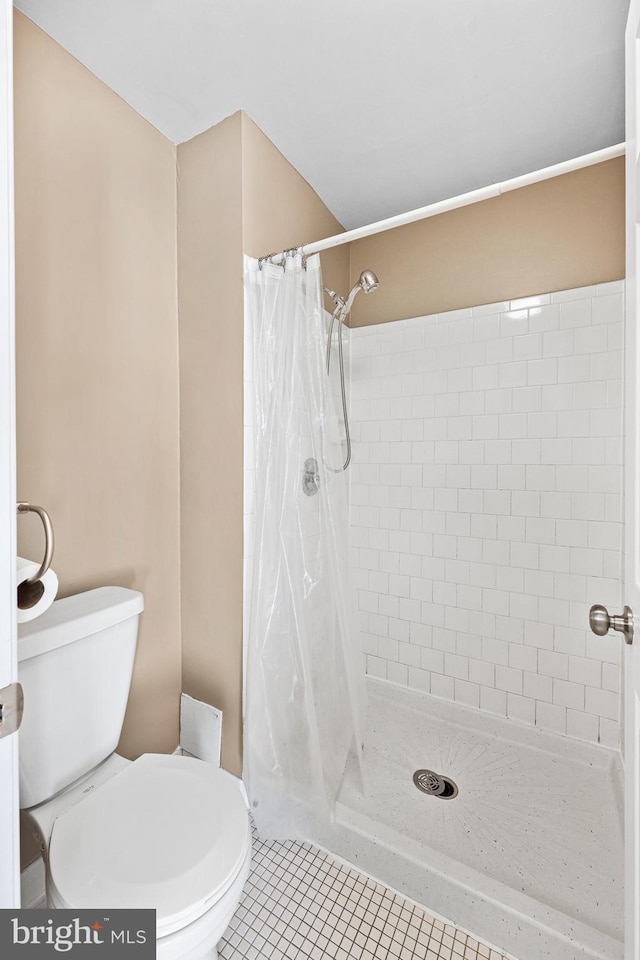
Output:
247,260,623,960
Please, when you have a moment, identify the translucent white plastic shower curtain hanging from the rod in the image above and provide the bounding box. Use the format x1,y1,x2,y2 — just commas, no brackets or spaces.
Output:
244,254,365,838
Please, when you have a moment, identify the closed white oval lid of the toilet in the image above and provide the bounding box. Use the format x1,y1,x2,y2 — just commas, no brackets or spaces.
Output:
49,754,250,936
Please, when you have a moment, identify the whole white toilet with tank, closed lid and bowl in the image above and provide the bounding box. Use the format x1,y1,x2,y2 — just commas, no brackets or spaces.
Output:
18,587,251,960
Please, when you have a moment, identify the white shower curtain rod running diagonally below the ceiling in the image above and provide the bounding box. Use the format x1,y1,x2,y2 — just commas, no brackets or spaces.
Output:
265,143,625,260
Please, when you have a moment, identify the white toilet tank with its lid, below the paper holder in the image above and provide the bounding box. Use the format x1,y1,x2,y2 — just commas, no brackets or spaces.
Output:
18,587,144,808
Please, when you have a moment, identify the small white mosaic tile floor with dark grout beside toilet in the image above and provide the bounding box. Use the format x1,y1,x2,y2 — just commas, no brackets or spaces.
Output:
218,832,505,960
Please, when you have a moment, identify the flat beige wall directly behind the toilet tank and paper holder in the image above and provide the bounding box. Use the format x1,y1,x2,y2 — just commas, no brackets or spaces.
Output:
15,12,180,757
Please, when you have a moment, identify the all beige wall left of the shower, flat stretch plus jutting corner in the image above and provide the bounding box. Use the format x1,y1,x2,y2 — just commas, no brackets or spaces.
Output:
15,7,348,804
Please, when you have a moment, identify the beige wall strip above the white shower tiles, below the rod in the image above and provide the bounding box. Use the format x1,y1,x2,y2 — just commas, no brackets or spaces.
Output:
351,158,625,326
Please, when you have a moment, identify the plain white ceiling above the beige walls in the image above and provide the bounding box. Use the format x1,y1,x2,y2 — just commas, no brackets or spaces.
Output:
15,0,629,231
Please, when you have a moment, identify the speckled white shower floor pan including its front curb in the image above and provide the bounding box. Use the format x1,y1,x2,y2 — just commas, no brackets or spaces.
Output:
318,681,624,960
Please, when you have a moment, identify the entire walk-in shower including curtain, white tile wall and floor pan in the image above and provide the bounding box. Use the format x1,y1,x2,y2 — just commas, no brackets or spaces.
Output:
245,255,623,960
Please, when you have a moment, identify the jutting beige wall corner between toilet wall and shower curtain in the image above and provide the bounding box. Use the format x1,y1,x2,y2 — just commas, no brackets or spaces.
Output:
178,113,348,773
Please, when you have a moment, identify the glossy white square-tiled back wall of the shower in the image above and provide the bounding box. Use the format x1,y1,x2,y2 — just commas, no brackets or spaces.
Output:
351,282,623,747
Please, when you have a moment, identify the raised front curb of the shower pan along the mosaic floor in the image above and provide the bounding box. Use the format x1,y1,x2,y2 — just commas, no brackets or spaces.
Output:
315,804,624,960
